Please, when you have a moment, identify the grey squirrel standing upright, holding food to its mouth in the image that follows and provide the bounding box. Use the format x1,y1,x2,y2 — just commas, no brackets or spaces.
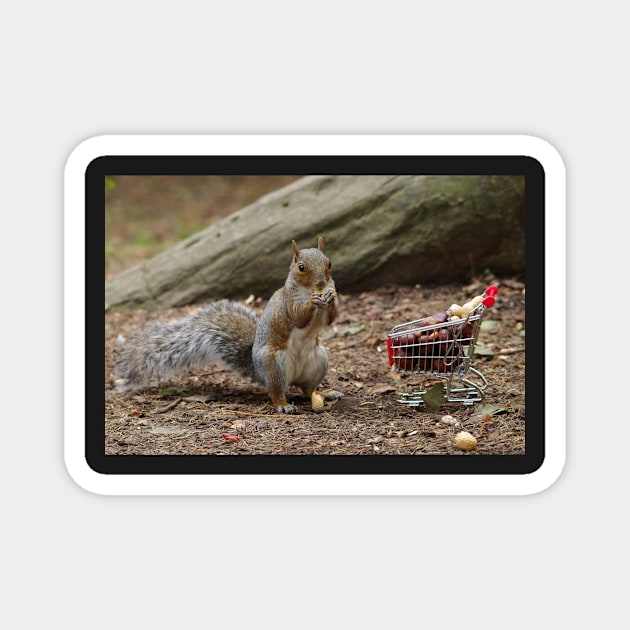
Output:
115,237,343,413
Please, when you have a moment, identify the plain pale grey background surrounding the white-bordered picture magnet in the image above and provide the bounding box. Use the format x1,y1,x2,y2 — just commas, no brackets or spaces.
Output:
0,1,629,629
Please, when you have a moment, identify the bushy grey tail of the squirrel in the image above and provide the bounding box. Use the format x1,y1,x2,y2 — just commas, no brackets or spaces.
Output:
116,300,257,391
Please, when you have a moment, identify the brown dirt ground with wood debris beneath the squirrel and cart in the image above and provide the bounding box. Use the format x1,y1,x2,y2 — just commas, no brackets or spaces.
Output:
105,178,525,456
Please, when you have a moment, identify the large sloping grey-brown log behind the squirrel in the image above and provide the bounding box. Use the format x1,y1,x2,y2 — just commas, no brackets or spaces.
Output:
105,175,525,310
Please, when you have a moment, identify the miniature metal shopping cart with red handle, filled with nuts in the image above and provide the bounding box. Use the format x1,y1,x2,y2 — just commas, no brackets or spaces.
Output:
387,285,497,407
